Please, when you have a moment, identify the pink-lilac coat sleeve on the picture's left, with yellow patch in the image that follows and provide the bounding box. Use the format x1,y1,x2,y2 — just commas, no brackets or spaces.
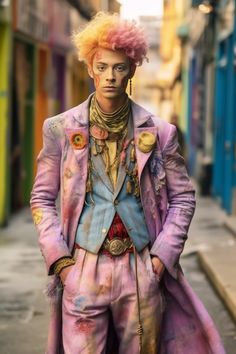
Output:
30,119,71,275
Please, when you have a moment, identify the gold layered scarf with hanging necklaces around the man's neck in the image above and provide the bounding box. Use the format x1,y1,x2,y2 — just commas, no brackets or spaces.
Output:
86,95,139,202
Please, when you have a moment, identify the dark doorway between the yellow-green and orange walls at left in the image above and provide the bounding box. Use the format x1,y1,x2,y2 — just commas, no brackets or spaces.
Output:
11,36,36,206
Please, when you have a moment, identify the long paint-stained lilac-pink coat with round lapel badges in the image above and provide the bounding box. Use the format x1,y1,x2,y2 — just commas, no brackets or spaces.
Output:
31,95,225,354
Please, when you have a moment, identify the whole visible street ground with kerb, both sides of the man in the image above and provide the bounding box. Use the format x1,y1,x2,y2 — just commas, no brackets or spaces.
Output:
0,197,236,354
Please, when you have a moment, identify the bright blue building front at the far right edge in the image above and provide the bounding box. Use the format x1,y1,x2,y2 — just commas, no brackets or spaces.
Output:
213,0,236,214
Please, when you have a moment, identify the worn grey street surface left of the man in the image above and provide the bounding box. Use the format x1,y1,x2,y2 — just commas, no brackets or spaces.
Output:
0,209,49,354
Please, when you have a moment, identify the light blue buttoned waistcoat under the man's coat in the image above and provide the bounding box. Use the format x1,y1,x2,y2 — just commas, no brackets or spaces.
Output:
76,123,149,254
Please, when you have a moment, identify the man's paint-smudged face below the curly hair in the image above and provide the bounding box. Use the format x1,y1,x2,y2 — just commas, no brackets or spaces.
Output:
88,48,135,99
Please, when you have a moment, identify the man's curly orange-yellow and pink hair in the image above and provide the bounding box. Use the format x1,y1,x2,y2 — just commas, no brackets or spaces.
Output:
72,12,148,66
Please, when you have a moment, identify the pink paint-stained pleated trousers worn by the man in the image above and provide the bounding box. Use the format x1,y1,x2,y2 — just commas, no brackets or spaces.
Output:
62,248,164,354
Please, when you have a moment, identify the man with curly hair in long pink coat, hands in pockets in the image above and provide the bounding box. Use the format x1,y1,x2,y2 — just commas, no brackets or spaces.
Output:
31,13,224,354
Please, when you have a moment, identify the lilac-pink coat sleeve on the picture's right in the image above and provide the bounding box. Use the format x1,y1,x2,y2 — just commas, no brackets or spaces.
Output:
150,125,195,278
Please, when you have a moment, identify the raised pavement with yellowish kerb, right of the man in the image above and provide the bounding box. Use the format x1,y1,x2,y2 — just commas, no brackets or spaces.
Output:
183,197,236,322
